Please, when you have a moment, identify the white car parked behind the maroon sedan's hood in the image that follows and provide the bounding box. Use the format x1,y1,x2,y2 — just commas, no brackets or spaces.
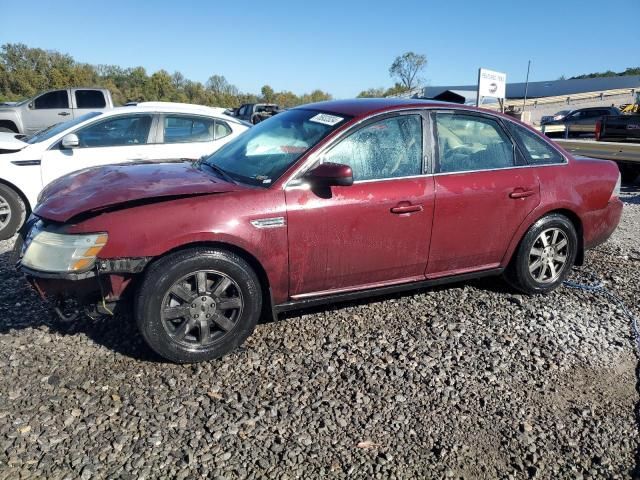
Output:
0,102,251,240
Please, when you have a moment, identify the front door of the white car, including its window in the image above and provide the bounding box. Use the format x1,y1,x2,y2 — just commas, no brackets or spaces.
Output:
41,113,153,185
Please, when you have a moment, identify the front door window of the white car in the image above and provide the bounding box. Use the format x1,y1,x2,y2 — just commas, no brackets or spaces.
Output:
76,115,152,148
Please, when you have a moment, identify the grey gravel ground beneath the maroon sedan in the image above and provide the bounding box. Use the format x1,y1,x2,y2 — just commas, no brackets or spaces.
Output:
0,182,640,479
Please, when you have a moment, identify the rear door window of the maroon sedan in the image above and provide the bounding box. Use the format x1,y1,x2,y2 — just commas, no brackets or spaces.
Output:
436,113,514,173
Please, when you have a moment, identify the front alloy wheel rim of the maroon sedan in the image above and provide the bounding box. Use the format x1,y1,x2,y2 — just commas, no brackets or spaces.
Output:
161,270,244,349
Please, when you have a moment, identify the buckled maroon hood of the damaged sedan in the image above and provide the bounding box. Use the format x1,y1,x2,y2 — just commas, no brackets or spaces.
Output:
34,162,248,222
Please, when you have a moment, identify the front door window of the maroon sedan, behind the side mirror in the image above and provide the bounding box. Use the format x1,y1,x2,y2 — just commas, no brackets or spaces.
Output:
324,115,422,181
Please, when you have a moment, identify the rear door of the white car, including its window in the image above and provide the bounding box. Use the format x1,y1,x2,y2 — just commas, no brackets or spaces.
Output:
148,113,233,160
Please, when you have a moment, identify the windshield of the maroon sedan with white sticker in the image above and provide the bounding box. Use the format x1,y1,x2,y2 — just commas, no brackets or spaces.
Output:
204,109,351,187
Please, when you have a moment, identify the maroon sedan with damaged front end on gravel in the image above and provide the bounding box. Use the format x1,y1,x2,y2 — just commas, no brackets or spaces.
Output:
16,99,622,362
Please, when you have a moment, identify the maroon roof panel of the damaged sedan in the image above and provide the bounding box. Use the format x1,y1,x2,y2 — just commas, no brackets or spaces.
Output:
296,98,460,117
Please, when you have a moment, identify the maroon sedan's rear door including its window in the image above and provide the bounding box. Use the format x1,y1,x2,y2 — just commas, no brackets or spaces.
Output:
426,111,540,278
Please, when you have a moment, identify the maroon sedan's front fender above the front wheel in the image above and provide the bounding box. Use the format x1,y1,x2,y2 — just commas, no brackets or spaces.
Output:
68,189,289,303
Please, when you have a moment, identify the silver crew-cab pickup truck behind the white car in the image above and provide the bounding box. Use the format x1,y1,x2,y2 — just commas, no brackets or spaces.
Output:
0,88,113,134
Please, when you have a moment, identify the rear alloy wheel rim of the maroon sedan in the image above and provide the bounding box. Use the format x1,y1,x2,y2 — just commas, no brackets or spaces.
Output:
529,228,569,283
